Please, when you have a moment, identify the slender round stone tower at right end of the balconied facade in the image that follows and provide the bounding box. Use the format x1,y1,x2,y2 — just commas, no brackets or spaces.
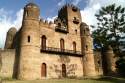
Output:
80,23,96,76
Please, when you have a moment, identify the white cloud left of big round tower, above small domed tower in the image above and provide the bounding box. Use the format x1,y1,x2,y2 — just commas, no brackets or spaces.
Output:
0,8,23,48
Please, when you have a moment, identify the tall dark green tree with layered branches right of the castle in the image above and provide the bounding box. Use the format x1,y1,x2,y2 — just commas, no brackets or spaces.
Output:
92,4,125,54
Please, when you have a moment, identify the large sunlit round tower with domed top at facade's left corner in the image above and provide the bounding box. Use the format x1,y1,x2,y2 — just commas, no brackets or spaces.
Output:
18,3,40,80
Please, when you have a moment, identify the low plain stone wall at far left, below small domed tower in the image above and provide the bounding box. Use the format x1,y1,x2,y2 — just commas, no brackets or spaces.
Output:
0,49,15,77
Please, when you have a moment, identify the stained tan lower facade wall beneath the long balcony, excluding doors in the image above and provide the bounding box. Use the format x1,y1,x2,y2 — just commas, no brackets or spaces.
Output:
36,53,83,79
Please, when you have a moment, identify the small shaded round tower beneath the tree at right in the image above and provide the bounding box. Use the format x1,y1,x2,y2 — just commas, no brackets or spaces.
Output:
105,46,116,75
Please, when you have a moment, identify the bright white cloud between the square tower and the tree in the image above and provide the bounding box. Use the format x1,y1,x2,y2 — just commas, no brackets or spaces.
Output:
81,0,125,30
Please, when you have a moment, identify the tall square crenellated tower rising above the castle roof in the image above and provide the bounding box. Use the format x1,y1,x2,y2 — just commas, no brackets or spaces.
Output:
58,4,81,34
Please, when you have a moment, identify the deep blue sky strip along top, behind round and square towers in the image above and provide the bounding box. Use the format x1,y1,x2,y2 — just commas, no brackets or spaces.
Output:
0,0,86,19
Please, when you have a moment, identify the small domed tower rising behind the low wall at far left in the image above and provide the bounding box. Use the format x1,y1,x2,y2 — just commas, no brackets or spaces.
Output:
4,27,17,49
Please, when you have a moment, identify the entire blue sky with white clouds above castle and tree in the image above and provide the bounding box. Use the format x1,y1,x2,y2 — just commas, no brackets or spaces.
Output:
0,0,125,48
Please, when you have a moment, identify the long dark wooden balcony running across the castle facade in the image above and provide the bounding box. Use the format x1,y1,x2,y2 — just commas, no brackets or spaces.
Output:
41,47,83,57
